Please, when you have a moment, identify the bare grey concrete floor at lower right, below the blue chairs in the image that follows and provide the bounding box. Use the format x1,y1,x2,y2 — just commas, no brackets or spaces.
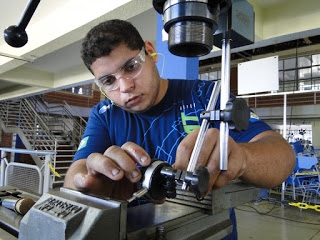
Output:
235,199,320,240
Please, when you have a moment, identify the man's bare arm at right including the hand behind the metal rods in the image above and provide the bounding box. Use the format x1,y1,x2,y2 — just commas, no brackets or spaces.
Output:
174,128,295,189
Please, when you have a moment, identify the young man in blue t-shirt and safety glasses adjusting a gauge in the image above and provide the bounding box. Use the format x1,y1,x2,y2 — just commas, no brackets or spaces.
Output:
64,20,295,239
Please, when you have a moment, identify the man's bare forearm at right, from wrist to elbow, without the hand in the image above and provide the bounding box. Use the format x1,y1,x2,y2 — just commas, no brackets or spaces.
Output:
240,131,295,188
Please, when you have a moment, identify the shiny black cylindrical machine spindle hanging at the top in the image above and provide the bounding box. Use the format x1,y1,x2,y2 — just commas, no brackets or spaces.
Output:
163,0,219,57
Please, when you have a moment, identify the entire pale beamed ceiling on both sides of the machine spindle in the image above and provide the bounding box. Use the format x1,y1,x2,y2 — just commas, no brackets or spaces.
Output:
0,0,320,101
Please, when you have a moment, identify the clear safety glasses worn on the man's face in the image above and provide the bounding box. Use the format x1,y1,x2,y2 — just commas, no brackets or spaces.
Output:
95,47,146,91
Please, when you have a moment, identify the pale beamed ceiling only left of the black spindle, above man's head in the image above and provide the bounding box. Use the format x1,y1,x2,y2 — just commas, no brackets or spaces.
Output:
0,0,157,100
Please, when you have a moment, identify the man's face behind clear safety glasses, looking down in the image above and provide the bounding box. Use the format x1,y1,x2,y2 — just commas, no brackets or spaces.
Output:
91,44,161,113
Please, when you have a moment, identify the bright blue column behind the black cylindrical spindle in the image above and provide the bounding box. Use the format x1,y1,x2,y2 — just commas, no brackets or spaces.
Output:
156,14,199,80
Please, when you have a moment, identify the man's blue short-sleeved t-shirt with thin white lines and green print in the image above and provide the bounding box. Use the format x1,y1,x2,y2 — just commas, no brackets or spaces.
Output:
74,79,271,239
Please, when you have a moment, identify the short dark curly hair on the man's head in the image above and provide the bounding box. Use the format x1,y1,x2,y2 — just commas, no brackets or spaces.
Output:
81,19,144,71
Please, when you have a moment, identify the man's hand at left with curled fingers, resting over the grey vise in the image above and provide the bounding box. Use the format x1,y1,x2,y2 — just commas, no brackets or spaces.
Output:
64,142,151,200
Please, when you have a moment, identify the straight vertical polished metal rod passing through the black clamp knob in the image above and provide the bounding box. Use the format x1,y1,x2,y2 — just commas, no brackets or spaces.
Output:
220,37,230,170
